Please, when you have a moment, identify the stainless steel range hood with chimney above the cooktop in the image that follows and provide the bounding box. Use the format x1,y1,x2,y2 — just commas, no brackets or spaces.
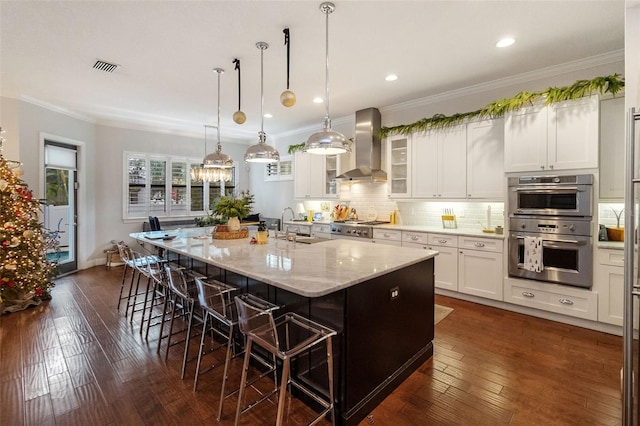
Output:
336,108,387,182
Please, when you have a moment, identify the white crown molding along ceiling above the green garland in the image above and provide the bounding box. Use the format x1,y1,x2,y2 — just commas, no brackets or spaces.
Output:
380,49,624,112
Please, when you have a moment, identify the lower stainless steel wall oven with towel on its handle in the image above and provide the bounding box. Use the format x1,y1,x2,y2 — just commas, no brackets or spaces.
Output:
509,216,593,288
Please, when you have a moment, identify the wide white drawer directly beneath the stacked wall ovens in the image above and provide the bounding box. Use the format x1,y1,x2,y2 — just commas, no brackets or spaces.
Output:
505,282,598,321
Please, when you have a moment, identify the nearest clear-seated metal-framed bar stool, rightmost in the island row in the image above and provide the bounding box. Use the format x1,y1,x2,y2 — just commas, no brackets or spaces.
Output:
235,295,337,426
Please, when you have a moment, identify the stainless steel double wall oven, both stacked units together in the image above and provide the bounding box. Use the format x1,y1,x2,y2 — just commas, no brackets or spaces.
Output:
508,174,593,288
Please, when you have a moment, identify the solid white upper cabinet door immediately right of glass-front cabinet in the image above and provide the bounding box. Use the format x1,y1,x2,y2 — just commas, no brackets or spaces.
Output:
411,131,438,198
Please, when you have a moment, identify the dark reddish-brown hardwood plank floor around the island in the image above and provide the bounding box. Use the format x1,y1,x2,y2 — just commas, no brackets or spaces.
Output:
0,267,622,426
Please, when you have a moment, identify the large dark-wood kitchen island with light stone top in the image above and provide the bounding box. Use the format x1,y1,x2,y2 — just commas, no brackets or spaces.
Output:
131,228,437,425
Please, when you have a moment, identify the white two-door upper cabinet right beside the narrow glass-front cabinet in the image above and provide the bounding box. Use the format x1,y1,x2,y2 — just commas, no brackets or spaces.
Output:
411,125,467,198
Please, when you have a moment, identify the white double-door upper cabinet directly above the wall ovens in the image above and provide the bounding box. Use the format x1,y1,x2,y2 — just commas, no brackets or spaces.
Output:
504,96,599,172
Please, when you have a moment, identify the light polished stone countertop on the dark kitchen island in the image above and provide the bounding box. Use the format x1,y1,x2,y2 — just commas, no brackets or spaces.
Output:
130,228,438,297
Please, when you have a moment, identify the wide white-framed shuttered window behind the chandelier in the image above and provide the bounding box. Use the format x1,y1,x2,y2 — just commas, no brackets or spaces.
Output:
123,152,237,219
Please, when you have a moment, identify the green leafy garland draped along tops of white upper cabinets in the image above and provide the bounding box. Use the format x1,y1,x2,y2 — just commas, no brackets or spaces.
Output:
289,74,624,154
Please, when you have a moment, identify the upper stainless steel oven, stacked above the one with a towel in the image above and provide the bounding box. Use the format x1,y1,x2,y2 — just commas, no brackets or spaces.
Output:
508,174,593,217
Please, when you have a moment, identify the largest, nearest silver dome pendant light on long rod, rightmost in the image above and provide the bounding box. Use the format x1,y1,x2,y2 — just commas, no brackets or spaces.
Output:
302,2,351,155
